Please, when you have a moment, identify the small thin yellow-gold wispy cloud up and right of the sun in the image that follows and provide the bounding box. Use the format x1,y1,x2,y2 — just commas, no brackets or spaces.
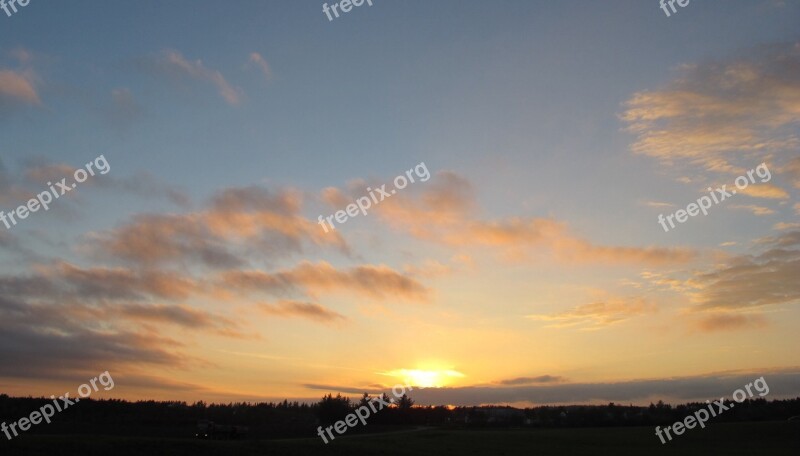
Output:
527,298,658,329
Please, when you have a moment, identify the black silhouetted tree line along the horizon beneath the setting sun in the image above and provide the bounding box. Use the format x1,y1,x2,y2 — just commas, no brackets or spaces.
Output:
0,393,800,438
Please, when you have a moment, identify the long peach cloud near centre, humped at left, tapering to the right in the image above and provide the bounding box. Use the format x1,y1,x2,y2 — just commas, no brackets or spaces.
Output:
328,171,697,265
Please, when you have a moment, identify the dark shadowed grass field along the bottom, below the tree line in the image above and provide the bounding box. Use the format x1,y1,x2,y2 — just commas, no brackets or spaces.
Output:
0,422,800,456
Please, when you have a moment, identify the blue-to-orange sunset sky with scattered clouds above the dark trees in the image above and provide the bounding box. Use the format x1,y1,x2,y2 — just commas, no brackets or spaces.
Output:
0,0,800,406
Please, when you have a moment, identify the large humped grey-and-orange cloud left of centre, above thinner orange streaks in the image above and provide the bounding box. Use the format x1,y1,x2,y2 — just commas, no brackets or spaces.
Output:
89,186,349,269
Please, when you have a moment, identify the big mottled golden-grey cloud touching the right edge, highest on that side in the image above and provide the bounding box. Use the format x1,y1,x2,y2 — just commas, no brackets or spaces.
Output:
621,43,800,183
